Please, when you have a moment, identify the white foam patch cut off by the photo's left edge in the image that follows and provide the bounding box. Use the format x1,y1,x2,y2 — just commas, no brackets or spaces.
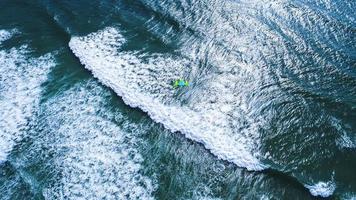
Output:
0,40,55,163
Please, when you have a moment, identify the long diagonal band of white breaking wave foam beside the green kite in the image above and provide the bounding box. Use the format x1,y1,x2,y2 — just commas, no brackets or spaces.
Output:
69,28,265,170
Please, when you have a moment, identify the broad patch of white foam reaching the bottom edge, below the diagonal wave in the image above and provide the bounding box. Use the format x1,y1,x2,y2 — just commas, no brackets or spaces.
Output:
40,80,155,199
